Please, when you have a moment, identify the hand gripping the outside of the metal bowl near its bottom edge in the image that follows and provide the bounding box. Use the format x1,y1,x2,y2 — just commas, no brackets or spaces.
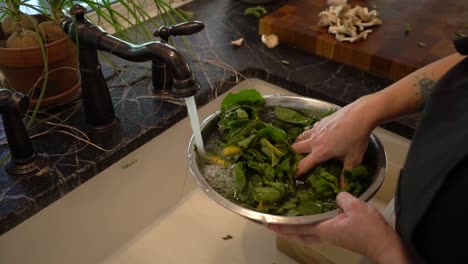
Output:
267,192,406,263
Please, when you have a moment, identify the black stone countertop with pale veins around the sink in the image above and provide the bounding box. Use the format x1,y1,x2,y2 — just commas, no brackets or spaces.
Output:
0,0,416,234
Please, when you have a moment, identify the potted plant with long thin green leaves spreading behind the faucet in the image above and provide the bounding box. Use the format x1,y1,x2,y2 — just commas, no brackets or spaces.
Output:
0,0,190,107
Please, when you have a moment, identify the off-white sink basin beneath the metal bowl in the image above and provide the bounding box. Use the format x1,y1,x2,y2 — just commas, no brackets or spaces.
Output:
0,79,409,264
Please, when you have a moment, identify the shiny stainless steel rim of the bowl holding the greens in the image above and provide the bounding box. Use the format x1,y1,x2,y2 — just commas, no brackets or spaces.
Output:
188,95,387,224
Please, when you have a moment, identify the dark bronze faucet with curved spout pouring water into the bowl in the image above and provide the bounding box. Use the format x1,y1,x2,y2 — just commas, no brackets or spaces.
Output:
62,4,203,131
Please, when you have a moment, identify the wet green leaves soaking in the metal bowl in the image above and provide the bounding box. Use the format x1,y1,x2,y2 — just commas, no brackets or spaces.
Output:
199,89,370,216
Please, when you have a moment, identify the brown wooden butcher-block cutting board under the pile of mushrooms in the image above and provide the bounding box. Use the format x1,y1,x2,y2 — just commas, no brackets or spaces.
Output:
259,0,468,80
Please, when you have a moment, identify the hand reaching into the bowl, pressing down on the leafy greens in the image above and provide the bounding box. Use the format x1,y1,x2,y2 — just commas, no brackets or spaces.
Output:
292,98,378,176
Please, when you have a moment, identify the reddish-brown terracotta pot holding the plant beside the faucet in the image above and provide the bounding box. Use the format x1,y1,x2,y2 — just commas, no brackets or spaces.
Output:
0,36,80,107
